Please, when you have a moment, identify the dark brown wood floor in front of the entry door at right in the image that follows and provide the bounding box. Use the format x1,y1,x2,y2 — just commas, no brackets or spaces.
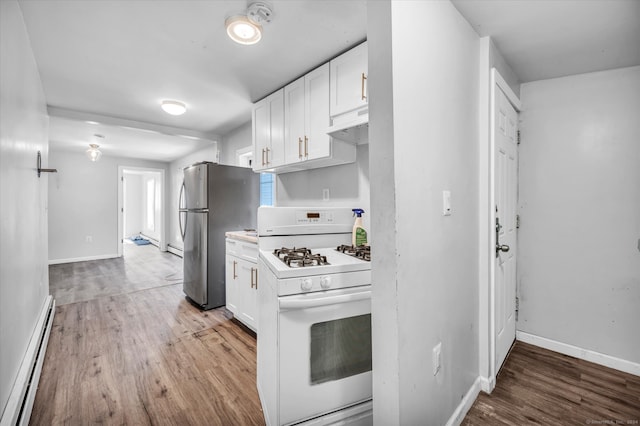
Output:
462,342,640,426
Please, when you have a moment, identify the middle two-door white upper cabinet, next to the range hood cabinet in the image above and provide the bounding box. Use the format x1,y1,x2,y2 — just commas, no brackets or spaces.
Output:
284,64,331,164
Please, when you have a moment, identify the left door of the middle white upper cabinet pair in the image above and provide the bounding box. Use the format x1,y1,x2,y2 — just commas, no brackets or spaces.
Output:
284,77,305,164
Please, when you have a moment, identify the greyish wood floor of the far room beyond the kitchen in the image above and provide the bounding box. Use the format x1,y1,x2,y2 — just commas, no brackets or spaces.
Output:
49,242,182,305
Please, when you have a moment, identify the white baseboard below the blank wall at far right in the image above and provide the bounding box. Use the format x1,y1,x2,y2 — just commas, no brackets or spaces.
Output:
516,331,640,376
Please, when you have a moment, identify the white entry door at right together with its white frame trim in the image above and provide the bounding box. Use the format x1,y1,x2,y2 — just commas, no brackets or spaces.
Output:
480,68,522,393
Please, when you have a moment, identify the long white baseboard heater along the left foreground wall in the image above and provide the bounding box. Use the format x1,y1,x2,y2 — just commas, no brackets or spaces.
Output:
0,296,56,426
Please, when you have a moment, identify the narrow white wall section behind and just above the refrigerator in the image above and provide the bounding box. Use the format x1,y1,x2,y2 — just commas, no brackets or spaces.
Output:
167,143,219,250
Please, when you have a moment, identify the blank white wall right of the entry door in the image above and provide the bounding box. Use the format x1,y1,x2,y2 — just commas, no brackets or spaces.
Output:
518,67,640,363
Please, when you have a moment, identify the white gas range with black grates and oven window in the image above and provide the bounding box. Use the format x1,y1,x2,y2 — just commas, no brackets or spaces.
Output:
258,207,372,425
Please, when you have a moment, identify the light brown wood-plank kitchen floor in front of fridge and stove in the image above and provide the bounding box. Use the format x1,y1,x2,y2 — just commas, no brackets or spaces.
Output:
30,284,264,425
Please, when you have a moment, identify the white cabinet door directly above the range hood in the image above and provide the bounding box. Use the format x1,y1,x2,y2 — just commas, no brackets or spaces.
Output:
330,42,368,117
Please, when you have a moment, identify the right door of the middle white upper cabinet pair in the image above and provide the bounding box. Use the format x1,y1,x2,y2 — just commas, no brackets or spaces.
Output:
304,64,331,160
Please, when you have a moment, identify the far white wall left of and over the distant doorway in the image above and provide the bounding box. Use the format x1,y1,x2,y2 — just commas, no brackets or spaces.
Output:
49,150,168,262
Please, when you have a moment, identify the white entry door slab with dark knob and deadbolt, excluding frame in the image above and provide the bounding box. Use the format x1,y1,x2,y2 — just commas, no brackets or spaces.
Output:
494,88,518,374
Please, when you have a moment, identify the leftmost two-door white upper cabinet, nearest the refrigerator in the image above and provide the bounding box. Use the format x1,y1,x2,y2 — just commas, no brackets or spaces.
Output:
251,89,285,171
